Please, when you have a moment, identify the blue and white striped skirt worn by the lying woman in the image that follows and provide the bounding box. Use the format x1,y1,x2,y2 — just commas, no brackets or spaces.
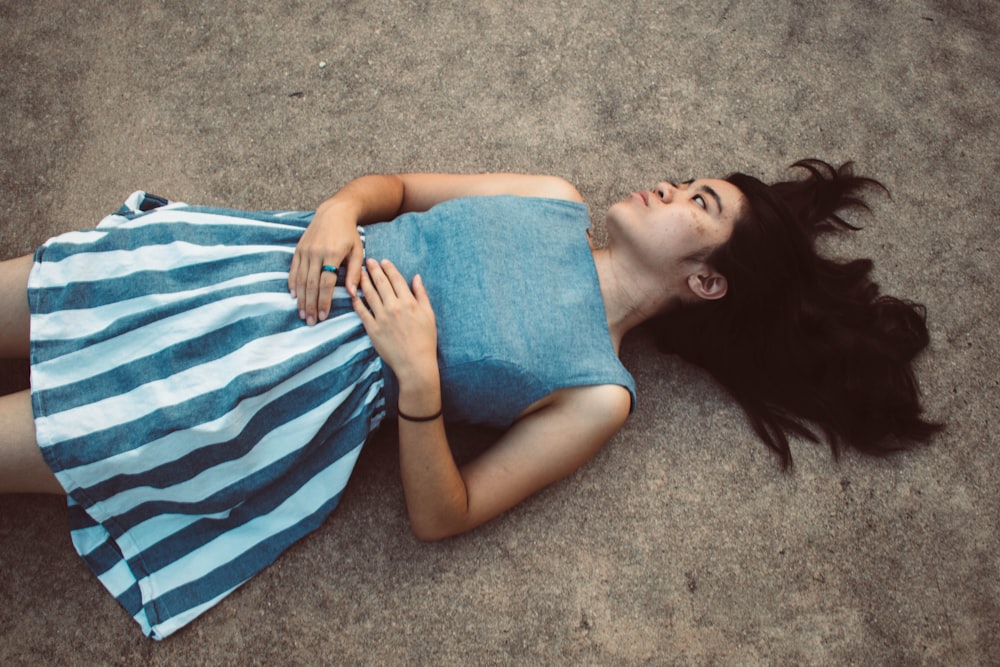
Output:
28,192,385,639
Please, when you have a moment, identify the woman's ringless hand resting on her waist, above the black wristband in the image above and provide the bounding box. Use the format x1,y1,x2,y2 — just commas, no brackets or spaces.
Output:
353,259,438,387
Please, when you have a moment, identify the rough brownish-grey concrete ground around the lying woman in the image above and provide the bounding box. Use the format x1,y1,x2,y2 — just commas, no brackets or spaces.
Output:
0,0,1000,665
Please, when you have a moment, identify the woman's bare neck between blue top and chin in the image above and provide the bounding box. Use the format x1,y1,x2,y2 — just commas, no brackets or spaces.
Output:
594,248,679,352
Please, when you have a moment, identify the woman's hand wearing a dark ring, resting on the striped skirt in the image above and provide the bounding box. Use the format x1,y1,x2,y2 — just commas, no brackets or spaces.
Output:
288,199,364,325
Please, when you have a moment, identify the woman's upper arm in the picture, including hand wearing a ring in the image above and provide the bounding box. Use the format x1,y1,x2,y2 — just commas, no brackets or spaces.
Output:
288,174,581,324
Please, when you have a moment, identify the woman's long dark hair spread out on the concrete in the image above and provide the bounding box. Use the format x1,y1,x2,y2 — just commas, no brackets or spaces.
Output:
651,159,941,467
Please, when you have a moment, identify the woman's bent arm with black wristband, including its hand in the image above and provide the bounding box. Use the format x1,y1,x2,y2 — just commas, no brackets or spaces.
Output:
355,259,631,540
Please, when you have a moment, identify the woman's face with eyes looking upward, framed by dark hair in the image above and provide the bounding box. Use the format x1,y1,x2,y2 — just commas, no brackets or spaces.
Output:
607,179,744,270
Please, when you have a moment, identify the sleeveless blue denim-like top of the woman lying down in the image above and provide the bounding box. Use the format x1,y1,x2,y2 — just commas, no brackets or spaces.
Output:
364,196,635,428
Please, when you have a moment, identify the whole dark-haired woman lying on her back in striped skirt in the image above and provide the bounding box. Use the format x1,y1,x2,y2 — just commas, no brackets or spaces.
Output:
0,161,936,638
